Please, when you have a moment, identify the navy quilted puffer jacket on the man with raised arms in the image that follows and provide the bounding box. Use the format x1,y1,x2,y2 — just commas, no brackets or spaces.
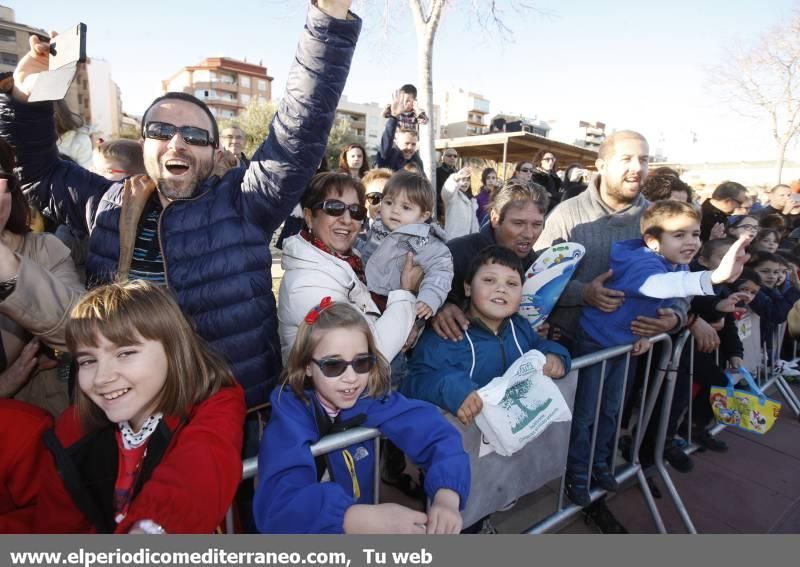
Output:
0,6,361,406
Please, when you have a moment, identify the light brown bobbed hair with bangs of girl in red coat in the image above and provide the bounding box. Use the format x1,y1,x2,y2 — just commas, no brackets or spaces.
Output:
66,281,236,430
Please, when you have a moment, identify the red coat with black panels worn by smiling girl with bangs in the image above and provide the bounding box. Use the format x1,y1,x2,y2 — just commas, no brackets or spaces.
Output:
36,386,245,533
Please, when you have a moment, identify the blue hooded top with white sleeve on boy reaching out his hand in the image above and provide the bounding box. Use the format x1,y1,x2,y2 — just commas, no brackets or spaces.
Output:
580,238,714,348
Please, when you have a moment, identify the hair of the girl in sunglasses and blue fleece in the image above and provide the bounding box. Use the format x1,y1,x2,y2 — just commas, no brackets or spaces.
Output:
282,303,391,400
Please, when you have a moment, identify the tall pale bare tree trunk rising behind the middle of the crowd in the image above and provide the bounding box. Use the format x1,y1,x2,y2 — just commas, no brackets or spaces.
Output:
408,0,533,190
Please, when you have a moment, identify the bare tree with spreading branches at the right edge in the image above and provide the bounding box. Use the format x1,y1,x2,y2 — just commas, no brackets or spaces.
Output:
713,12,800,183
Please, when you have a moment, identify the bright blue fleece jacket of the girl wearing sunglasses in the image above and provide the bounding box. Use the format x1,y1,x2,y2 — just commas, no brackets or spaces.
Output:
253,388,470,533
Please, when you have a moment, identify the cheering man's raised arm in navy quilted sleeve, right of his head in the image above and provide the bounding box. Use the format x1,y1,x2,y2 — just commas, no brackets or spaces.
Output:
242,0,361,232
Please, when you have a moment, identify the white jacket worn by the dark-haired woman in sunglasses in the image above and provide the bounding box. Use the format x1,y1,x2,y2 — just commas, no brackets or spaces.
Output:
278,235,417,363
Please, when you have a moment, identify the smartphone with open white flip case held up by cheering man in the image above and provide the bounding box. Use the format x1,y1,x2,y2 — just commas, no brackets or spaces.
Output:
28,24,86,102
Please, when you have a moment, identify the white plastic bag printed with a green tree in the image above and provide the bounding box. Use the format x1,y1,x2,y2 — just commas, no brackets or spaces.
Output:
475,350,572,457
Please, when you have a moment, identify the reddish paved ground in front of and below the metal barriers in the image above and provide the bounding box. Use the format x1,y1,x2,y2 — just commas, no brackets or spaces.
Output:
493,380,800,534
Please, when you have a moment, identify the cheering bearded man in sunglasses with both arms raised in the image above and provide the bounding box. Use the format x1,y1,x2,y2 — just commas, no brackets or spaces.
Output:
0,0,361,407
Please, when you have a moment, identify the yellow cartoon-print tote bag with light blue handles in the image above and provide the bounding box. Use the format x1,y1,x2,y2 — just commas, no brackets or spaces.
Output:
710,367,781,435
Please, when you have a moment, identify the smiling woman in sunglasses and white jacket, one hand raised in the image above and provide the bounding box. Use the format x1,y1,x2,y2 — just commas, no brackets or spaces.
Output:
278,173,423,362
